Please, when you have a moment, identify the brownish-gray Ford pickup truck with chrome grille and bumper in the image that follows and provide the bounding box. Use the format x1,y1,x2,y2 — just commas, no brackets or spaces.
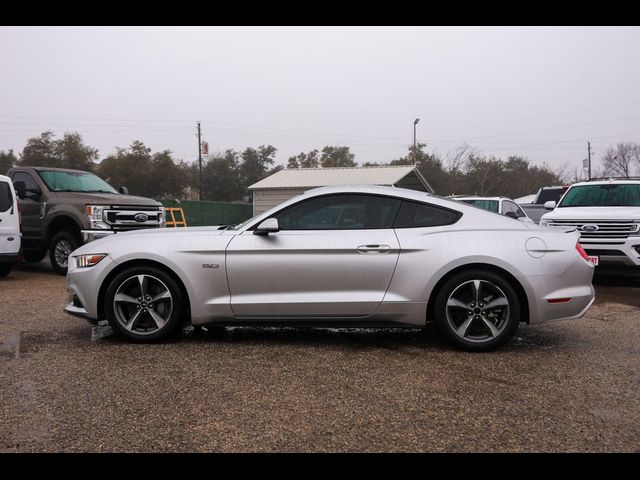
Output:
7,167,165,275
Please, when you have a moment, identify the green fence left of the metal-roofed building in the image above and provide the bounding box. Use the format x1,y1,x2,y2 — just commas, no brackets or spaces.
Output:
158,200,253,227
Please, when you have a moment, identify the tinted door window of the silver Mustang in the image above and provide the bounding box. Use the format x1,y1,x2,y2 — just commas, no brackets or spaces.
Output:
273,194,400,230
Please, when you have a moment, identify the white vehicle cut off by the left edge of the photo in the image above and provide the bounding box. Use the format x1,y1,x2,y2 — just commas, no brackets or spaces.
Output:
0,175,22,277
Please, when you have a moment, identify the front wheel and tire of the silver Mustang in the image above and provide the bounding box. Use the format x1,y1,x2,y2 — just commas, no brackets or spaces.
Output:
104,266,186,343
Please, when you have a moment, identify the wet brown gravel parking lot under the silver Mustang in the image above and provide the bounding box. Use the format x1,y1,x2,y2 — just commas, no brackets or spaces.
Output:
0,262,640,452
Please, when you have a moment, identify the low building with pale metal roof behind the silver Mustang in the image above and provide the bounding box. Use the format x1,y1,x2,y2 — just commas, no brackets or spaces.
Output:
249,165,433,215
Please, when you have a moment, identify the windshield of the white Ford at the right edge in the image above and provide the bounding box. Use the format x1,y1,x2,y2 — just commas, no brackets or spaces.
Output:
558,183,640,207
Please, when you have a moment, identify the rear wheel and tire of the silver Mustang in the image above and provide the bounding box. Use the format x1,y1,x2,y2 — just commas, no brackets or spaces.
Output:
433,269,522,352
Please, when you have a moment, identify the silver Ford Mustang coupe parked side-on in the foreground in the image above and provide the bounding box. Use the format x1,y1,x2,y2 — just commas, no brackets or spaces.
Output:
65,187,594,351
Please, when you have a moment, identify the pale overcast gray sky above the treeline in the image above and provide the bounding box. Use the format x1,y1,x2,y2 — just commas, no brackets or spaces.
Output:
0,27,640,174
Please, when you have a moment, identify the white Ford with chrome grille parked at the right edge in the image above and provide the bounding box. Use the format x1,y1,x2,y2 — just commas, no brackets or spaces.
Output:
540,179,640,267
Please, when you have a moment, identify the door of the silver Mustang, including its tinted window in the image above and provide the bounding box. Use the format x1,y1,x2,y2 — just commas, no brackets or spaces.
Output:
226,194,400,318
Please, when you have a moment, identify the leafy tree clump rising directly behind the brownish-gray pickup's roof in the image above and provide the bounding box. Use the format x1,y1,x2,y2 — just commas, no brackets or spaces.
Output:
19,131,98,172
